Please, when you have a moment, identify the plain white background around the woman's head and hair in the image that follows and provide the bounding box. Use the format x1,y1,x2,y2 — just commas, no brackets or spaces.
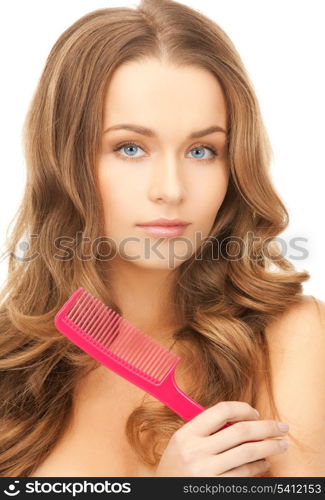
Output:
0,0,325,300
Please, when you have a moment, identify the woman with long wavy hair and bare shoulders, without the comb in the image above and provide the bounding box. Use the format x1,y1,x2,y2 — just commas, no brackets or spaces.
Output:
0,0,325,477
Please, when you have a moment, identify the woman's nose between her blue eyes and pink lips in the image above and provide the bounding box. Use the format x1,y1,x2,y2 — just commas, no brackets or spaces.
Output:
149,155,185,204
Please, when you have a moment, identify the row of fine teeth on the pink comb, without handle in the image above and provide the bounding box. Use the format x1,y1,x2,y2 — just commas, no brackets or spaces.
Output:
62,288,179,384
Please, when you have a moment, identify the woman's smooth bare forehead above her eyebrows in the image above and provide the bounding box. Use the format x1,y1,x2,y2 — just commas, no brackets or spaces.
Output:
104,59,227,130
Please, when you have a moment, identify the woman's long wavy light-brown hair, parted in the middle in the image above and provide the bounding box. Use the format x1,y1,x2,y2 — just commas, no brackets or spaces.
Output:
0,0,309,477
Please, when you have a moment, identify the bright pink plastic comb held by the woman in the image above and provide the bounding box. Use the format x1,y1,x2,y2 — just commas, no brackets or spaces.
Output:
54,288,232,429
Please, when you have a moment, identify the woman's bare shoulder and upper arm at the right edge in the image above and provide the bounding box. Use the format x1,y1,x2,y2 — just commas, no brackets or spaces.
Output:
261,295,325,477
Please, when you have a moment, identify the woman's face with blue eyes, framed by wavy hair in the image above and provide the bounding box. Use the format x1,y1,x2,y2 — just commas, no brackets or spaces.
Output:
98,58,229,269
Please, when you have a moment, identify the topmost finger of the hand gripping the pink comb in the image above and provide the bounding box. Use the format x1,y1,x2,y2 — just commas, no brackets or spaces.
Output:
181,401,259,436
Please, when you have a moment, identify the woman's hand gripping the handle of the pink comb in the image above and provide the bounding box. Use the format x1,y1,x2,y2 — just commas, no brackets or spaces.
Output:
155,401,287,477
